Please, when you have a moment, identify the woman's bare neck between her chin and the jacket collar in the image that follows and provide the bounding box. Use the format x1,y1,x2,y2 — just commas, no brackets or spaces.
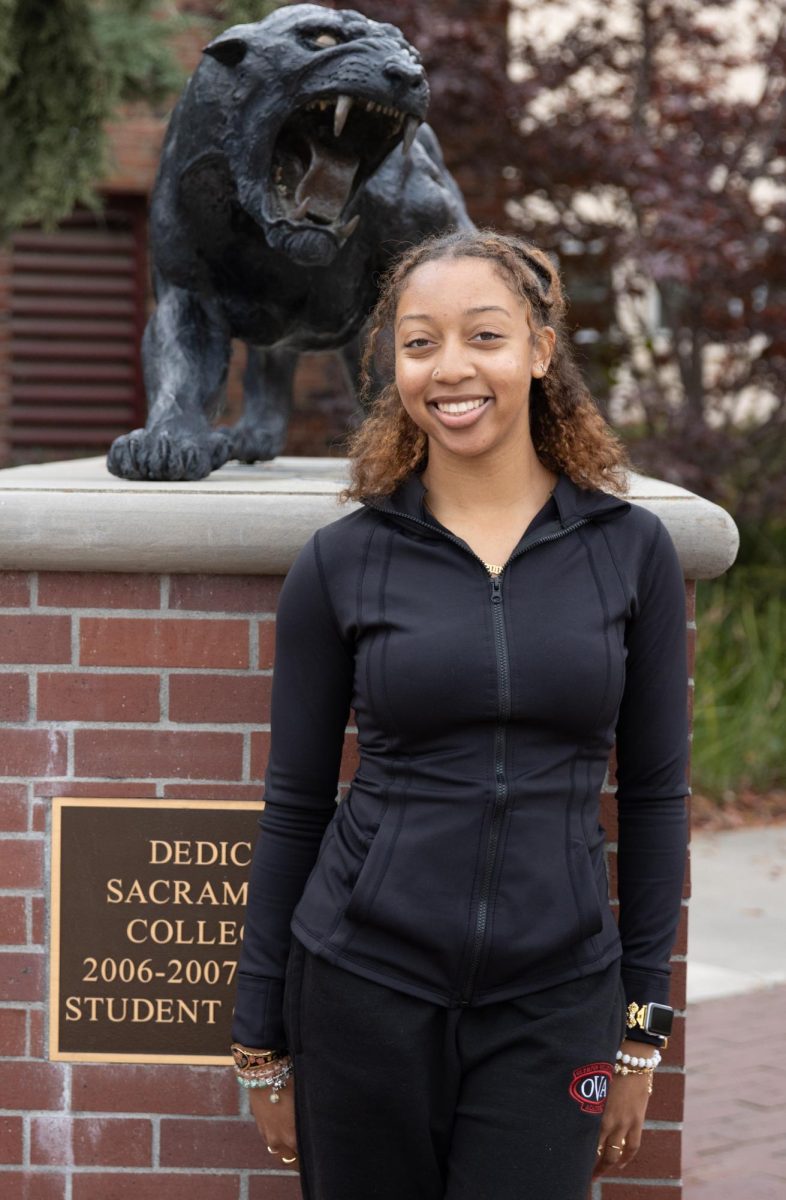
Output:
422,439,557,514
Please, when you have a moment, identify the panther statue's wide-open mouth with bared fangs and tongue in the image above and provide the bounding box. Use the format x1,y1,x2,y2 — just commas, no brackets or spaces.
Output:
269,92,420,242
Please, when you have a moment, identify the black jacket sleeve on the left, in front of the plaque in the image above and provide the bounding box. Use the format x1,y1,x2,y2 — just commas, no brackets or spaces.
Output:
232,534,354,1050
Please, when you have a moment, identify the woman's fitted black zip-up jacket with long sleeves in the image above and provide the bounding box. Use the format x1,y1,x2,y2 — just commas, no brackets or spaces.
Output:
233,474,689,1049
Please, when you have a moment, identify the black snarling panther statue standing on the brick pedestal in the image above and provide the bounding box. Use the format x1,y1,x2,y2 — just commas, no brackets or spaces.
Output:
107,5,470,479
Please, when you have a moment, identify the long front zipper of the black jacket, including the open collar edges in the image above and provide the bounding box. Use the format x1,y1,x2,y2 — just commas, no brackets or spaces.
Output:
374,512,589,1008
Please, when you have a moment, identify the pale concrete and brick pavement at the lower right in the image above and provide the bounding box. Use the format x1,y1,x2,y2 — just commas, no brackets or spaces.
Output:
683,824,786,1200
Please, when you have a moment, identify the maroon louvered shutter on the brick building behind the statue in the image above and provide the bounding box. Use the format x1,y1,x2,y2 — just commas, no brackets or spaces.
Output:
8,199,146,462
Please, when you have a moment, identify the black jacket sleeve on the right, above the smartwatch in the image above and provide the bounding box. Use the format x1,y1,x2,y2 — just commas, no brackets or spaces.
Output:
617,520,690,1042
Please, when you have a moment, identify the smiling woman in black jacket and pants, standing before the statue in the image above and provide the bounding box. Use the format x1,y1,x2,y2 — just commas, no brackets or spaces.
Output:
233,232,688,1200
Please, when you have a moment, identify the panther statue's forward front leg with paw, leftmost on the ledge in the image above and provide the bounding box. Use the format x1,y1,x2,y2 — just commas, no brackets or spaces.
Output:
107,288,232,479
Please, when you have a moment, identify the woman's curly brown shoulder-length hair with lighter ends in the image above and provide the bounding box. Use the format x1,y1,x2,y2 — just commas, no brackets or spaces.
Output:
341,229,630,500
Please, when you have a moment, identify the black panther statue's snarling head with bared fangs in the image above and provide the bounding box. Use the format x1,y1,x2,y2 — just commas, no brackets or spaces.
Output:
198,5,428,265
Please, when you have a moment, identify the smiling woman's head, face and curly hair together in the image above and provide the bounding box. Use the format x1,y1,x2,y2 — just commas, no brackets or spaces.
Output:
344,230,628,499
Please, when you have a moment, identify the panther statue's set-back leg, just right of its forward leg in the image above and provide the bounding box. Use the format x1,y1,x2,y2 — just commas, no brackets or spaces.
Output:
226,346,299,462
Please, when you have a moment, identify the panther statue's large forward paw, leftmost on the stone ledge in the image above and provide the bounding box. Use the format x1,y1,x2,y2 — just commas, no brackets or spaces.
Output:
107,428,232,479
